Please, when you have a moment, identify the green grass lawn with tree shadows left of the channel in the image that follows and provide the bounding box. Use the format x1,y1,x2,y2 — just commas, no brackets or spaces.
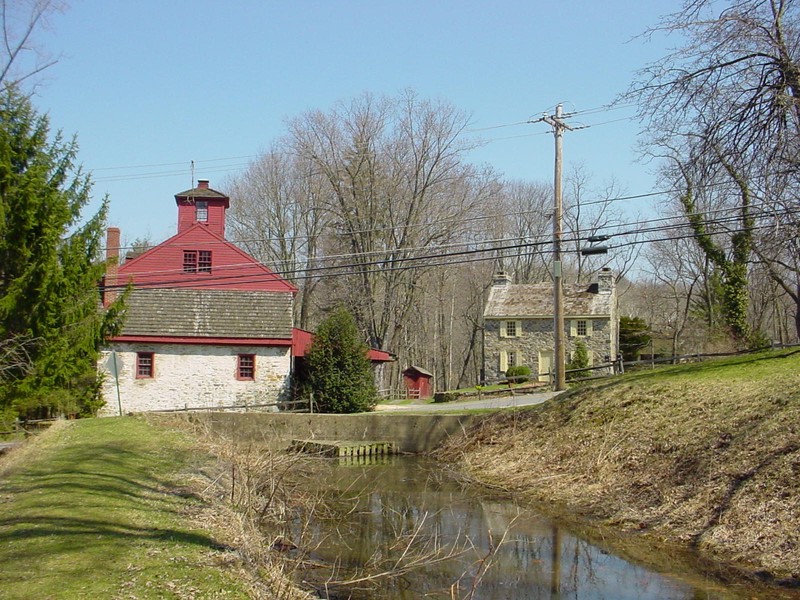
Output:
0,418,253,599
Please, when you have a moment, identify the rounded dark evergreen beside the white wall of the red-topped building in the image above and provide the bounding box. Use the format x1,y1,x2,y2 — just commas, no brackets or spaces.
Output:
306,308,376,413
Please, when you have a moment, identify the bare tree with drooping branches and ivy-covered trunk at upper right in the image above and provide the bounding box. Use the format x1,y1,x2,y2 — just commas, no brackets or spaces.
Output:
627,0,800,338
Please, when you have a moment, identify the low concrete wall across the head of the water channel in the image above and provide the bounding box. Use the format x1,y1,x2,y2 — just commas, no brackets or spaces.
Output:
186,413,481,453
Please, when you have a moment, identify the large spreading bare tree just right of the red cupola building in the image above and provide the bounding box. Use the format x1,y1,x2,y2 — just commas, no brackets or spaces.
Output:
290,92,499,348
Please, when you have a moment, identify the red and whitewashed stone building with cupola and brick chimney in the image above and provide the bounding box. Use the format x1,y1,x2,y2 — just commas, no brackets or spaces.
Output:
98,180,297,415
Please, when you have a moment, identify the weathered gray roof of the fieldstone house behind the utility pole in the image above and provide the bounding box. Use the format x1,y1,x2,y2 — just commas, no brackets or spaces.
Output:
483,283,615,318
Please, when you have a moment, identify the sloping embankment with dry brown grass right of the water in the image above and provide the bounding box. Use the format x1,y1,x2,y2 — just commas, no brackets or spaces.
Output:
440,350,800,585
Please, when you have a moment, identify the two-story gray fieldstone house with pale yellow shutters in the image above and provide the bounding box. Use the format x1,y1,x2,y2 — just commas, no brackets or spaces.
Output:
483,269,619,383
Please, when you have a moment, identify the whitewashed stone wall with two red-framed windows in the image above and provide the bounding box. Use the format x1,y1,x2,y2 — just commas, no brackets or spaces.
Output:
98,344,291,416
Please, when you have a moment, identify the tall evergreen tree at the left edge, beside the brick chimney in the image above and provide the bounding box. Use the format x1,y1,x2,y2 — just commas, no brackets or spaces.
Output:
0,86,118,420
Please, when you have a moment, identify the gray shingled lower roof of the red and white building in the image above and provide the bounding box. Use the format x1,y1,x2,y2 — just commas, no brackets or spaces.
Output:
122,289,292,339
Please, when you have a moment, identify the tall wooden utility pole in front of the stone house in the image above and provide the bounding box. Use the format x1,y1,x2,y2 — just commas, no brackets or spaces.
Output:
542,104,572,392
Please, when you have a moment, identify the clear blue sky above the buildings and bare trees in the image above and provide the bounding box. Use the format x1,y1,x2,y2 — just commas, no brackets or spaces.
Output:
35,0,677,242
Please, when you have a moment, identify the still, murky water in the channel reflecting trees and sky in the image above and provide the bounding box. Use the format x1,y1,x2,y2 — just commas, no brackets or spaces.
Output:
292,457,780,600
